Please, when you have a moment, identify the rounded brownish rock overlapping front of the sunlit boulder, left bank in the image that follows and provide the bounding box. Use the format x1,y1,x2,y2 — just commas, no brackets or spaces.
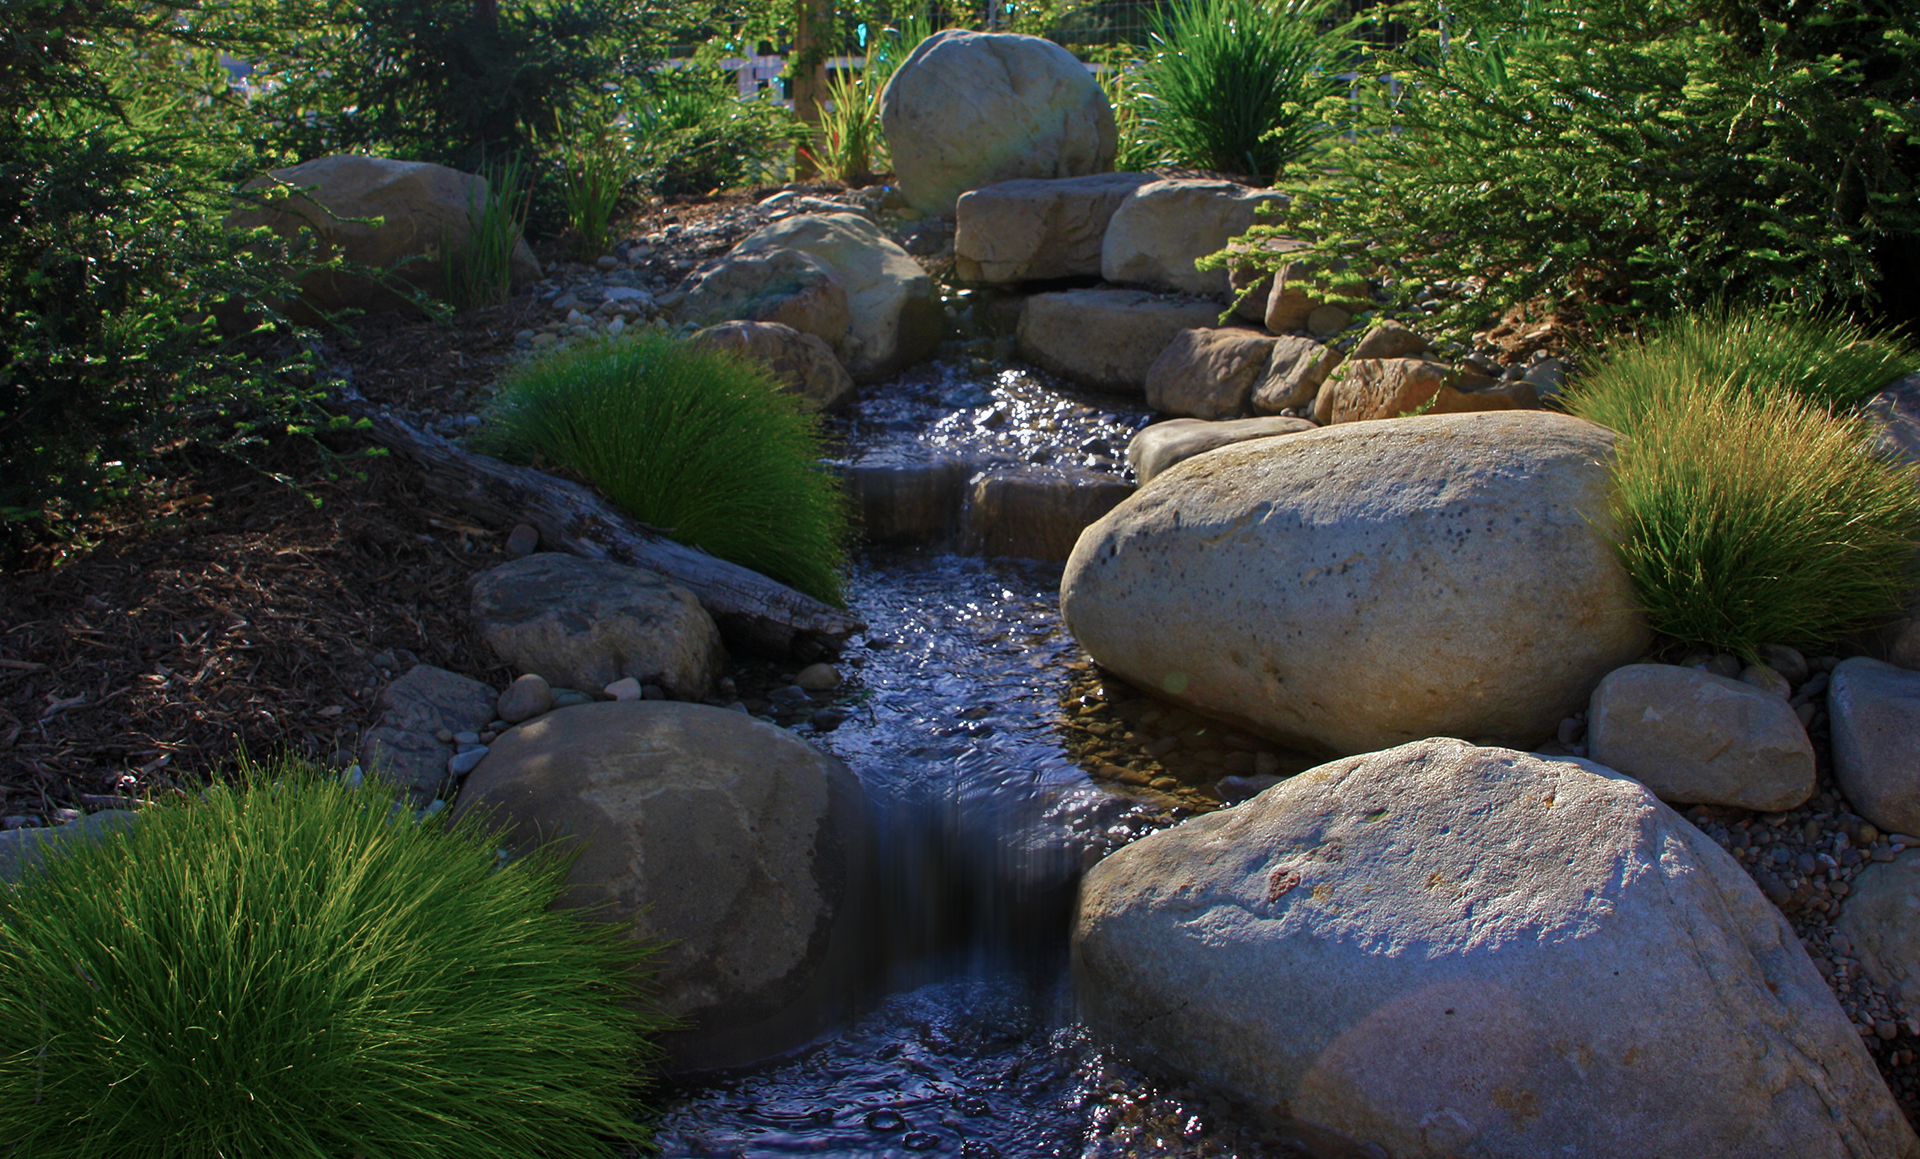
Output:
676,249,852,355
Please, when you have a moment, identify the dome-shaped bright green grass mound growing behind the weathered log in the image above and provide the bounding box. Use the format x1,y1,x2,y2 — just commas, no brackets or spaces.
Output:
474,332,847,604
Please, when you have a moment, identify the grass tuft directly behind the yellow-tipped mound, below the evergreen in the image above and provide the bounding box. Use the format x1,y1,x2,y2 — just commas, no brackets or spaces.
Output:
1563,305,1920,434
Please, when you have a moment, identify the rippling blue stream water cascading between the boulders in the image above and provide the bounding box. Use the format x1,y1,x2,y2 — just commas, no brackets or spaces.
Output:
657,365,1367,1159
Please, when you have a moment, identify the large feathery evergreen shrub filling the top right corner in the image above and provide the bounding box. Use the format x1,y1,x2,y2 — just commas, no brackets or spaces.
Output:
1221,0,1920,336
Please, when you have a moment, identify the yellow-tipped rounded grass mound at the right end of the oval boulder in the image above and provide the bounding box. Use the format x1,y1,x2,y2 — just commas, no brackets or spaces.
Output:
1613,390,1920,660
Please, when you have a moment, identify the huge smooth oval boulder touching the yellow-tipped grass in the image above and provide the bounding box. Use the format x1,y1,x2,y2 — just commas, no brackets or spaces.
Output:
1060,413,1653,754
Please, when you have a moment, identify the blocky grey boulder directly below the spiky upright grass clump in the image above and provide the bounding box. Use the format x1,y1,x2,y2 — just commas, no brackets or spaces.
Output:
1100,178,1279,301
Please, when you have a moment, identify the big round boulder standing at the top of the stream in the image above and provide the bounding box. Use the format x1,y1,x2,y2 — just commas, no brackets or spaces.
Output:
879,29,1119,217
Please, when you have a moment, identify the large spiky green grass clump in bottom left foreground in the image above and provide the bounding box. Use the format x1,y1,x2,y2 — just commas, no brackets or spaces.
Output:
0,762,662,1159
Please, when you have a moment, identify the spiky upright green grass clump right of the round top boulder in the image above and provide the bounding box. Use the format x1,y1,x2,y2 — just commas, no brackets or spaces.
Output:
1139,0,1346,182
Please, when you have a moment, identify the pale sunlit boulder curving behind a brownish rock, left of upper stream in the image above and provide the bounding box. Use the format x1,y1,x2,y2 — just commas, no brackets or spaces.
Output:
733,213,947,382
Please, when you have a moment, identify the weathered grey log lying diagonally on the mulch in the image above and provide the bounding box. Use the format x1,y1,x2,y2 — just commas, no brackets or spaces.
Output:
340,386,866,660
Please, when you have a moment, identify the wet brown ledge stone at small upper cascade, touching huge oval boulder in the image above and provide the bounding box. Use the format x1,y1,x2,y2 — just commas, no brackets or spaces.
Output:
966,466,1133,560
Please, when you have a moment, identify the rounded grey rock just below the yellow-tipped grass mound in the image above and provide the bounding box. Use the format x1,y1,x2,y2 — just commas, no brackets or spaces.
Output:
1586,664,1814,814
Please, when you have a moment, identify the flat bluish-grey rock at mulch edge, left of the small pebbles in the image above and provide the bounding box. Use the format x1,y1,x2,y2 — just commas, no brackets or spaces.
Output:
359,663,499,808
